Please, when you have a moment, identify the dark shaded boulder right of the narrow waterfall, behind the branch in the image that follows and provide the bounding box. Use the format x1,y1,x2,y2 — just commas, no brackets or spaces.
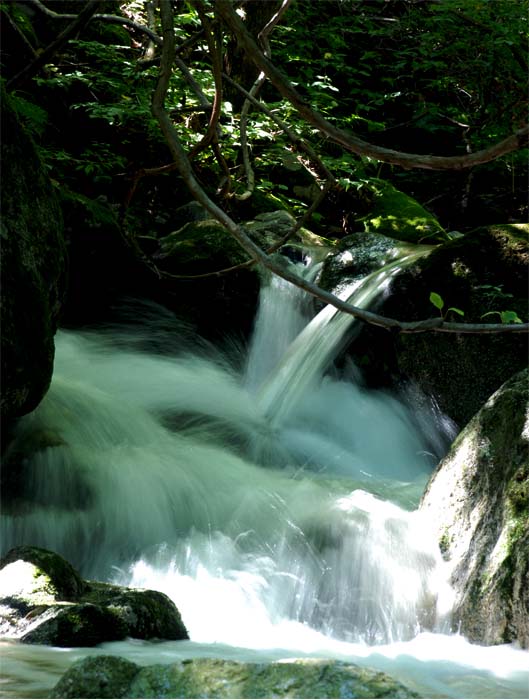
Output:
336,225,529,427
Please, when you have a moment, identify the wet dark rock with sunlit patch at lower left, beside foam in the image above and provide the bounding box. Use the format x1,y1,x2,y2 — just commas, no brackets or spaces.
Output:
0,547,187,647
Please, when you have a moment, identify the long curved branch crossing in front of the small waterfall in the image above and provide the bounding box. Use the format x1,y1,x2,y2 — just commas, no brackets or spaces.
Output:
152,0,529,333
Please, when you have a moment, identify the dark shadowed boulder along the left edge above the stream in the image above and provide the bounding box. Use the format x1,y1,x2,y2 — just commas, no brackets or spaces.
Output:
0,85,66,419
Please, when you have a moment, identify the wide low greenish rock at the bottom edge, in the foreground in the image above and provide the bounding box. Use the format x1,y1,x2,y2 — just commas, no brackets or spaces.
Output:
51,656,419,698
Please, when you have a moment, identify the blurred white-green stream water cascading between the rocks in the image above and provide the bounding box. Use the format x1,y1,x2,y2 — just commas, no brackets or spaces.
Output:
0,265,528,698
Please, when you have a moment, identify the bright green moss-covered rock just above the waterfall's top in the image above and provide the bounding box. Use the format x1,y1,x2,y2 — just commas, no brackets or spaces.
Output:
363,180,448,243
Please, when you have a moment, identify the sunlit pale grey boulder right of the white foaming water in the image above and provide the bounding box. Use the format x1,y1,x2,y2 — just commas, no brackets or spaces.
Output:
421,370,529,648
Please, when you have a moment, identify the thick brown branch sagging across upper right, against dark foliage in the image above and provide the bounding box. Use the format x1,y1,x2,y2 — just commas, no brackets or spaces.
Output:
214,0,529,170
